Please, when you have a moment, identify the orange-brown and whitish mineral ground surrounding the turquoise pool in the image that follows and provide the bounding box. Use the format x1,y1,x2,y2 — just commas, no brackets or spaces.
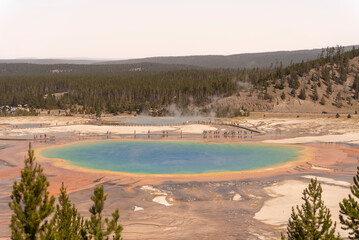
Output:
0,117,359,239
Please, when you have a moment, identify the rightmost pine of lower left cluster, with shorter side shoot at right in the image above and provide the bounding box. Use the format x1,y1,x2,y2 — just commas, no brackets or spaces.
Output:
86,185,123,240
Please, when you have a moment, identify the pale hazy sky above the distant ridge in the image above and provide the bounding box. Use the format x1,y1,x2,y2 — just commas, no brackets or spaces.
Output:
0,0,359,59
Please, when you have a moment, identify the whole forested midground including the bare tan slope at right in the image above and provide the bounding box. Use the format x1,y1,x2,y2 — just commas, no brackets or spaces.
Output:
0,47,359,116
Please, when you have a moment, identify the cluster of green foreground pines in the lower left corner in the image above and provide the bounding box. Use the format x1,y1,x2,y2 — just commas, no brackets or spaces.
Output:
9,144,123,240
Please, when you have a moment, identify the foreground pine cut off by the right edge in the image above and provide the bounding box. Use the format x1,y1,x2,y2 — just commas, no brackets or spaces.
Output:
339,167,359,239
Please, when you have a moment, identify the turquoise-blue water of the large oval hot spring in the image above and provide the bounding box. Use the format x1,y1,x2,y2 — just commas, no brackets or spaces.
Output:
42,141,303,174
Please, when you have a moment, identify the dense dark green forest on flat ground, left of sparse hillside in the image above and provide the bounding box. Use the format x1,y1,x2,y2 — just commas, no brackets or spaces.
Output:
0,70,237,114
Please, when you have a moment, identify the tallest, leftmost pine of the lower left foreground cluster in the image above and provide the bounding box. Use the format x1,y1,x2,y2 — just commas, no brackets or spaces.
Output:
9,144,55,240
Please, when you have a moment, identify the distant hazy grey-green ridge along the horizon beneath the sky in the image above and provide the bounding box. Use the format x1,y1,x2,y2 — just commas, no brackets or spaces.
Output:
0,45,359,69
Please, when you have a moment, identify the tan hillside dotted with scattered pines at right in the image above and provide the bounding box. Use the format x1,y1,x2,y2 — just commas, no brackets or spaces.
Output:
213,47,359,113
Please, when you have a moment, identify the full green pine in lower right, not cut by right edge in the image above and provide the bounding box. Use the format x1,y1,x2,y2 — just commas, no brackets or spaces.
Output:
282,179,340,240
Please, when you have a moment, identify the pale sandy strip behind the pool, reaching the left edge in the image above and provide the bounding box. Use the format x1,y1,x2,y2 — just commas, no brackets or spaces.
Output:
0,116,217,138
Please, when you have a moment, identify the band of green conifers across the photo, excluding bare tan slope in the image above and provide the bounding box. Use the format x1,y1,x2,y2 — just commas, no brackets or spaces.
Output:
0,47,359,116
